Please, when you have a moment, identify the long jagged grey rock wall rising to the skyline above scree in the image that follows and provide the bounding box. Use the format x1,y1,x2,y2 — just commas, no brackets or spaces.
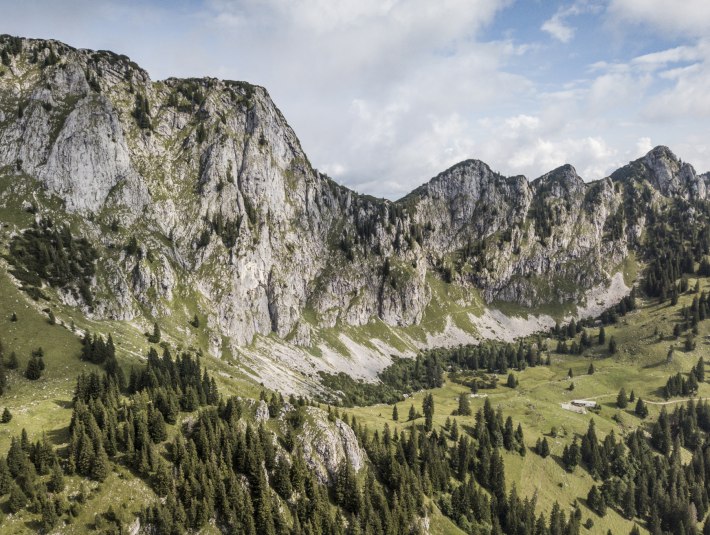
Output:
0,37,710,386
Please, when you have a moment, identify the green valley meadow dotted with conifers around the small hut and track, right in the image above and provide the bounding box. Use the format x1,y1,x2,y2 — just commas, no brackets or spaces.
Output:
348,279,710,534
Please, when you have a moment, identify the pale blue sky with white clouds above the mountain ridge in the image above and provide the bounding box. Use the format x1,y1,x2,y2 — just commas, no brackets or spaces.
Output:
0,0,710,199
